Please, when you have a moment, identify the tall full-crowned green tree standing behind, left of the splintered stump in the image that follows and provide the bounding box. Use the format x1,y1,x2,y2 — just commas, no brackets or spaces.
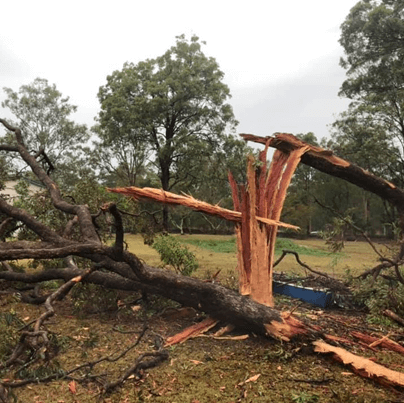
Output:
98,35,237,228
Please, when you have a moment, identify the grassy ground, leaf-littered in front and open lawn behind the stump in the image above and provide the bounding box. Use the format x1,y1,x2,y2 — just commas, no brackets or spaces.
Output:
0,235,404,403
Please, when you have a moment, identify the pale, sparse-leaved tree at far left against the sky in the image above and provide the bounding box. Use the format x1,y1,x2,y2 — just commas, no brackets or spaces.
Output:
1,78,89,185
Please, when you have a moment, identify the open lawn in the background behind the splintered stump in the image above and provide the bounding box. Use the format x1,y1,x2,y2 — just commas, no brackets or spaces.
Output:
126,235,384,277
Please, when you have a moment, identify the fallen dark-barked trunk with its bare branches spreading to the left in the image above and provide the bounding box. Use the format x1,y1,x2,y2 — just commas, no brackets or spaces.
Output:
0,119,306,339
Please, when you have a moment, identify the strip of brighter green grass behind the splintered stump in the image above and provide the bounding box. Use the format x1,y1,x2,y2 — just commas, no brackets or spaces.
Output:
178,237,330,256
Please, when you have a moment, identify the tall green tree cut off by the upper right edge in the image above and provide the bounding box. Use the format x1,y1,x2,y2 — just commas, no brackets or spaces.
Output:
334,0,404,186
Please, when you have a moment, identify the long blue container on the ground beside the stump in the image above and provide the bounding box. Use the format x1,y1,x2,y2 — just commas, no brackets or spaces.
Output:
273,281,333,308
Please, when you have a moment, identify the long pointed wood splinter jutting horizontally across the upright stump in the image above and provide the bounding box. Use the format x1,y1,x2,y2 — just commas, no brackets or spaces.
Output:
107,186,299,230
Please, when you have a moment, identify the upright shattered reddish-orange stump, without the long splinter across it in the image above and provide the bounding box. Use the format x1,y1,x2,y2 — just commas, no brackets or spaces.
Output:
229,140,309,306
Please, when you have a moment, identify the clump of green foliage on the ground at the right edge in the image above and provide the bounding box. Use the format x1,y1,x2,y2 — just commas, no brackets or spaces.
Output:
351,276,404,322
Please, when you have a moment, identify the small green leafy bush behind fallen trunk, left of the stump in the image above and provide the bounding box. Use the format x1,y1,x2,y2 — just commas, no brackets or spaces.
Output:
153,235,199,276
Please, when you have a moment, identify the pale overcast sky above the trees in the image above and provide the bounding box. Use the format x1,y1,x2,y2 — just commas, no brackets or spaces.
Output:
0,0,357,142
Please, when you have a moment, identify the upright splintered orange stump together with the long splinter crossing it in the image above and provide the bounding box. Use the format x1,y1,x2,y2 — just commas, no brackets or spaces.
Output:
108,135,312,307
